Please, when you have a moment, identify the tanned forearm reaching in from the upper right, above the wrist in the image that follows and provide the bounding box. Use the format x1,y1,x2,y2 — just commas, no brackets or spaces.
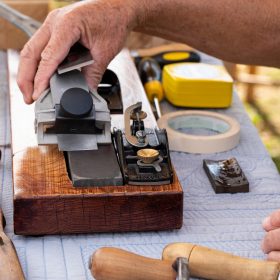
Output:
135,0,280,67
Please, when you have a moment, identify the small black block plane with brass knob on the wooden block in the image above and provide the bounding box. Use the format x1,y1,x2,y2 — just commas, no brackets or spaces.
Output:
113,102,173,185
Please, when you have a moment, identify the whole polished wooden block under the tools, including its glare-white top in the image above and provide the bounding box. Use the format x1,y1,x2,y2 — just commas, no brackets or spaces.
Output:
9,51,183,235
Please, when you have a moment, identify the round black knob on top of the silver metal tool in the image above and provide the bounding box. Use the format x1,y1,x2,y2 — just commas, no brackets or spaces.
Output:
60,88,93,118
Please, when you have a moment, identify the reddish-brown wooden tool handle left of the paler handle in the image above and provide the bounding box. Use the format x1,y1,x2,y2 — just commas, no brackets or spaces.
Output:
90,248,176,280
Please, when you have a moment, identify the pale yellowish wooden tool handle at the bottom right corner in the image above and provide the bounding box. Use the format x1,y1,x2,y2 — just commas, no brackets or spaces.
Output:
162,243,280,280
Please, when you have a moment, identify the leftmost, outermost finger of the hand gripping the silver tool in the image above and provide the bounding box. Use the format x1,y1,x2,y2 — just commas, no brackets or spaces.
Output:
17,25,50,104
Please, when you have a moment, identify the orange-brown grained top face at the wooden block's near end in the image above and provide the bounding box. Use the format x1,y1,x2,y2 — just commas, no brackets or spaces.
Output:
13,145,181,199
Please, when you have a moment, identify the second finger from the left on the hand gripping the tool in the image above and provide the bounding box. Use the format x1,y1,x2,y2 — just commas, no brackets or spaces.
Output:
32,22,79,100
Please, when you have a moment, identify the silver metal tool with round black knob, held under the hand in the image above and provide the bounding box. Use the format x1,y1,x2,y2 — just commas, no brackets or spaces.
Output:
35,70,111,151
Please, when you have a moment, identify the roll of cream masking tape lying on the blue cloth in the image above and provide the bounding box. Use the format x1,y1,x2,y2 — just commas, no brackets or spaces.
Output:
157,111,240,154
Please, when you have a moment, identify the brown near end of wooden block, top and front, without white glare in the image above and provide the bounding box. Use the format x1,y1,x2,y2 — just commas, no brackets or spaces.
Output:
14,146,183,235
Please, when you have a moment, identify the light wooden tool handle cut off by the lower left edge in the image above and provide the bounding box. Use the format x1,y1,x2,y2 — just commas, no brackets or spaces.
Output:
0,210,25,280
